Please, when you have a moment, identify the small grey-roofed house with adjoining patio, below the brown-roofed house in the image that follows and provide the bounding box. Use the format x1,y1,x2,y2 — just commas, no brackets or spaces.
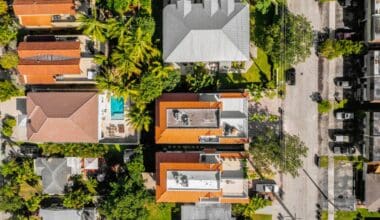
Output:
34,157,99,195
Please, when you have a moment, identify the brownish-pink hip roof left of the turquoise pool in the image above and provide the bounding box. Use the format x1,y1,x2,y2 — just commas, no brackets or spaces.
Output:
27,92,98,143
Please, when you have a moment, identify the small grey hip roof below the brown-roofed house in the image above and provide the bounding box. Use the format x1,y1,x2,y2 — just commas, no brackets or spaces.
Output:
34,158,71,194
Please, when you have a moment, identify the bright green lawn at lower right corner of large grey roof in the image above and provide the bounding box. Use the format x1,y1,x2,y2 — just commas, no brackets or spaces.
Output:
219,48,272,85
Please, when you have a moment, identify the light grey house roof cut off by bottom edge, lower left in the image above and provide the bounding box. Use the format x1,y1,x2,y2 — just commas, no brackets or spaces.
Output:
38,208,98,220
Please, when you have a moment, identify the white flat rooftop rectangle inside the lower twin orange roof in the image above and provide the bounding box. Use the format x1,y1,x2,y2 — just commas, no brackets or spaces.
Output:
166,171,220,190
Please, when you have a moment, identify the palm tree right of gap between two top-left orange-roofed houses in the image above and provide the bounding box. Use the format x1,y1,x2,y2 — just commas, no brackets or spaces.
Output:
78,10,107,43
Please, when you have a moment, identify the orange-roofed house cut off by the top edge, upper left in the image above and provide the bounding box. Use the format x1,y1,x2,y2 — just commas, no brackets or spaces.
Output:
13,0,91,28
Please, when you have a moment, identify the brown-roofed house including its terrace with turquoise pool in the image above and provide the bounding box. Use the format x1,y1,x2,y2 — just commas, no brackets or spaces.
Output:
26,91,139,144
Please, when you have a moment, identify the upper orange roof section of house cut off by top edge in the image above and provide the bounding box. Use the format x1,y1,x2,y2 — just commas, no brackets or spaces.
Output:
13,0,75,16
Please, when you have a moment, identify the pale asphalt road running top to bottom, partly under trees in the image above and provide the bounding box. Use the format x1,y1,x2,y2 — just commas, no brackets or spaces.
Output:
273,0,328,220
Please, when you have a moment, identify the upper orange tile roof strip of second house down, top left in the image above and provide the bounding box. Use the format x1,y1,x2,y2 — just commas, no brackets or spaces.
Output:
17,41,80,59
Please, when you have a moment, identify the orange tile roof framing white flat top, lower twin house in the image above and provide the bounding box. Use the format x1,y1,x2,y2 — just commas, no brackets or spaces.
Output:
156,152,249,203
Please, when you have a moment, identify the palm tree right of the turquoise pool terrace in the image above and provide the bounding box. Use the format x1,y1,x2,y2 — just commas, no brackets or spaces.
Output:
127,105,153,131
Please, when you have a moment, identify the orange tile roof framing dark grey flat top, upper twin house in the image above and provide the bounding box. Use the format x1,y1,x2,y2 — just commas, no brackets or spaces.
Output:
155,93,249,144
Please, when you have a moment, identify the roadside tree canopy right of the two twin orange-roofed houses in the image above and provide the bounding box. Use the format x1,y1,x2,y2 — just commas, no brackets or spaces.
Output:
249,128,308,176
